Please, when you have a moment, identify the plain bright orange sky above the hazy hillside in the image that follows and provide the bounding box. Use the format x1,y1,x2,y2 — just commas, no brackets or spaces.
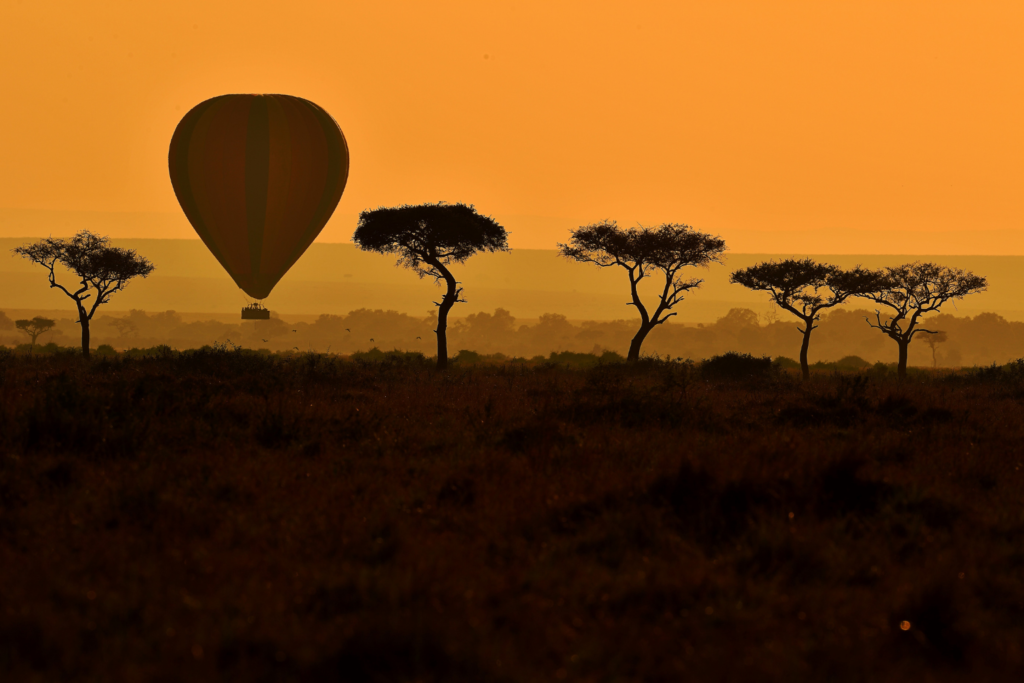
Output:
0,0,1024,253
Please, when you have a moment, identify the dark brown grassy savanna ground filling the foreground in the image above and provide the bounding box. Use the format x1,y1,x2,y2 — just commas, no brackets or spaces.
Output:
0,350,1024,682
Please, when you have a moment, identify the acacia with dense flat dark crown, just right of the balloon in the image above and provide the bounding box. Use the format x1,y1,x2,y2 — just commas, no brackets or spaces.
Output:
352,202,509,370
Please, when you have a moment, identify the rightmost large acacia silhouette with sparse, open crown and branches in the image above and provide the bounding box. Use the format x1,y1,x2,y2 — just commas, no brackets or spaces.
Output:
857,261,988,380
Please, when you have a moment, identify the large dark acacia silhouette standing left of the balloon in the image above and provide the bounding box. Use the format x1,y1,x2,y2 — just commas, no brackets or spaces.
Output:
11,230,153,357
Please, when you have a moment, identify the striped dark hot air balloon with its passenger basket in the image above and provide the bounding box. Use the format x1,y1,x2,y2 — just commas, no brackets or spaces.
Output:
168,95,348,318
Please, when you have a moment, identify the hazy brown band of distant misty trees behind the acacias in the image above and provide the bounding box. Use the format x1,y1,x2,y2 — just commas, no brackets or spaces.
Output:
0,308,1024,368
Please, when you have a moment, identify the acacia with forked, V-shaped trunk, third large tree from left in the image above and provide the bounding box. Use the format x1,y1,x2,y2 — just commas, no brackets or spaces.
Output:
558,220,725,360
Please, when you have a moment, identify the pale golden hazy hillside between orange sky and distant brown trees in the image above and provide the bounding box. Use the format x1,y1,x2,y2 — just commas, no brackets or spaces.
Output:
0,238,1024,323
